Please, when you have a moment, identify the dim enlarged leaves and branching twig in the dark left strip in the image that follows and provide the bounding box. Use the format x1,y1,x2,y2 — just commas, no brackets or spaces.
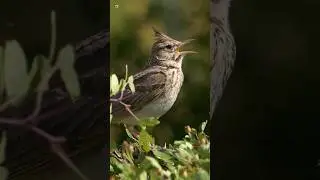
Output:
0,11,87,180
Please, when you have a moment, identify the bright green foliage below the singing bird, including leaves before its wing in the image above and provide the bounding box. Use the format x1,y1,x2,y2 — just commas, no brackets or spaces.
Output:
109,71,210,180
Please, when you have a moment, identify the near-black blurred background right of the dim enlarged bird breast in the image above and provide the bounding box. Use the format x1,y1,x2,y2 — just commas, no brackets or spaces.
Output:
211,0,320,180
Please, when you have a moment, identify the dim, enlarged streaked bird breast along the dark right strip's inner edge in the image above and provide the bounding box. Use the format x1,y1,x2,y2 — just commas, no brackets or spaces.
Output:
210,0,236,119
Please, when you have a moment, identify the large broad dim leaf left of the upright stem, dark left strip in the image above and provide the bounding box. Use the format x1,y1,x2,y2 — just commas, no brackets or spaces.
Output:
4,40,29,99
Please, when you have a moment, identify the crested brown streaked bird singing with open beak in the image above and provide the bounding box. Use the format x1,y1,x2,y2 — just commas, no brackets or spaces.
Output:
111,27,196,125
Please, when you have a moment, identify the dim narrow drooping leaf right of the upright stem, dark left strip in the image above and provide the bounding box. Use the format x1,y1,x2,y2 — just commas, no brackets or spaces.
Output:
57,45,80,100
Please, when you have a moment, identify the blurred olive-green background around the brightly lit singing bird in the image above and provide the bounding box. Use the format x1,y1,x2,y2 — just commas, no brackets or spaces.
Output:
110,0,210,144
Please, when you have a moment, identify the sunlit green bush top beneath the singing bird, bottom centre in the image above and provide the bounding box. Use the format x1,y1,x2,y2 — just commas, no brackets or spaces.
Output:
111,119,210,180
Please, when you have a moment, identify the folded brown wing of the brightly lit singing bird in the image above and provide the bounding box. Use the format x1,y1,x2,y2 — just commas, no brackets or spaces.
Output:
111,67,167,116
